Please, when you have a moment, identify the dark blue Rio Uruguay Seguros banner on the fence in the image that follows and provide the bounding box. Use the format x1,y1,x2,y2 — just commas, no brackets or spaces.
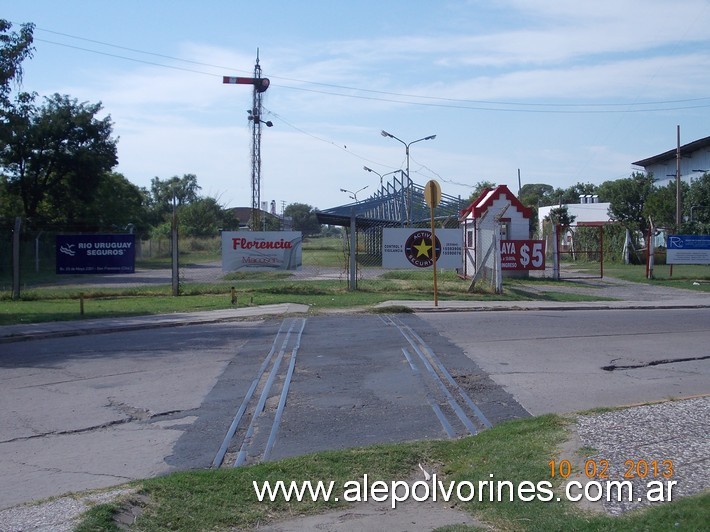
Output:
57,234,136,274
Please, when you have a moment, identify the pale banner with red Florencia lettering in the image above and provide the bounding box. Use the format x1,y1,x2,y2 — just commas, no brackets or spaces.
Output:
222,231,303,272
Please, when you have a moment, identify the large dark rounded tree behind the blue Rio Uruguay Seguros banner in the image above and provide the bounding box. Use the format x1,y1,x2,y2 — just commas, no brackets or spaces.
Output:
0,94,117,221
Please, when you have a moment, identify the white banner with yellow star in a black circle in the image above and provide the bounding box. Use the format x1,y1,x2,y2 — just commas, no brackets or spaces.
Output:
382,228,463,270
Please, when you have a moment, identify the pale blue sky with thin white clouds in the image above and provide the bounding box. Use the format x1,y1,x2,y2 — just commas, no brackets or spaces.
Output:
5,0,710,212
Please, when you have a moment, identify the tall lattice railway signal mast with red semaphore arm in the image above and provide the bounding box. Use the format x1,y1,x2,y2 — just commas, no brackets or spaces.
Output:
222,48,274,231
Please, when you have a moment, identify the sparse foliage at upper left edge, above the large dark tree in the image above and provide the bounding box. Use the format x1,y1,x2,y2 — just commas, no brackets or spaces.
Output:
0,19,34,110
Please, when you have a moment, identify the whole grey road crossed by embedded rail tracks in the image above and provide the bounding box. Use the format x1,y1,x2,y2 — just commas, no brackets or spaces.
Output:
0,309,710,508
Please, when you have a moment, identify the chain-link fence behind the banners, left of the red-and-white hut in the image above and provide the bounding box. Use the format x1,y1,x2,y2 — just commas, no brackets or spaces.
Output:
0,218,470,299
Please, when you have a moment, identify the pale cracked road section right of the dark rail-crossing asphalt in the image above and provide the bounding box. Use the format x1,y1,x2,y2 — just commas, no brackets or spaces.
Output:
421,308,710,415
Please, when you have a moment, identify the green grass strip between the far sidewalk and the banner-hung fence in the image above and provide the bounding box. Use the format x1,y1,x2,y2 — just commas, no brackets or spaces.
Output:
0,272,620,325
